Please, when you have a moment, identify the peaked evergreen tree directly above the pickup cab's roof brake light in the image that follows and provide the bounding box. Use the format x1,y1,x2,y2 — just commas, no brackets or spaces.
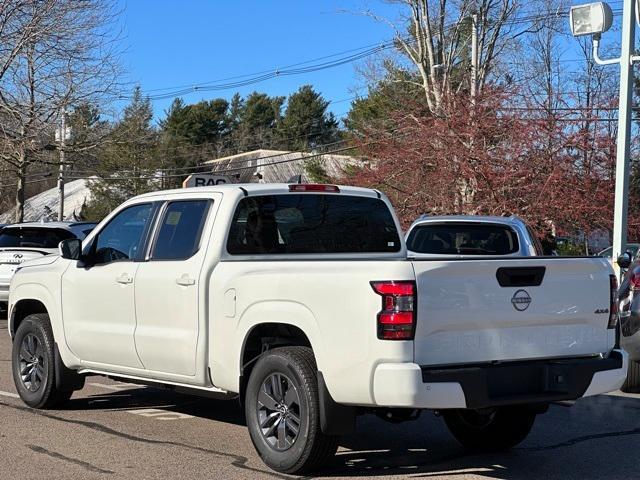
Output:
277,85,339,151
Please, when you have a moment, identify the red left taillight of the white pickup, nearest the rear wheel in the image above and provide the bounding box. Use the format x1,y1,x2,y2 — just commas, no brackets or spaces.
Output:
371,281,416,340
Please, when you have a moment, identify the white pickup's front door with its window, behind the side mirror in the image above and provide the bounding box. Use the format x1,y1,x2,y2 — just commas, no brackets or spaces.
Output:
61,203,153,368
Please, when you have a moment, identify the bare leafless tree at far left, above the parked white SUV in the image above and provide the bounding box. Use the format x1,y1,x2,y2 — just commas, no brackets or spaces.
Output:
0,0,120,221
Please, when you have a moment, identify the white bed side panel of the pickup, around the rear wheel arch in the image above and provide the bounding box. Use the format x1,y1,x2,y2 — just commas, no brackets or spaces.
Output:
209,260,413,405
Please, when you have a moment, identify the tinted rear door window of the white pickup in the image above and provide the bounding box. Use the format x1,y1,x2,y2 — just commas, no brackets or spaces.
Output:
151,200,209,260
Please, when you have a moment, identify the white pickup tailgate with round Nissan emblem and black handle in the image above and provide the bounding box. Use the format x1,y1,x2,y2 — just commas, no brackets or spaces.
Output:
412,257,613,366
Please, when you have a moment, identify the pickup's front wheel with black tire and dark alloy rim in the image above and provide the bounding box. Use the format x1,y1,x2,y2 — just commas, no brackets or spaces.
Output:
11,313,73,409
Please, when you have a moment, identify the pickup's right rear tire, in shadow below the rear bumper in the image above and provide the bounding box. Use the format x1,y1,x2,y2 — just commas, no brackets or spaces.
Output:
443,407,536,452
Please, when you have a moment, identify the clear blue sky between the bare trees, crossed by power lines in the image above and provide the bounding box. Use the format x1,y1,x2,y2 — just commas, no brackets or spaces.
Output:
121,0,397,124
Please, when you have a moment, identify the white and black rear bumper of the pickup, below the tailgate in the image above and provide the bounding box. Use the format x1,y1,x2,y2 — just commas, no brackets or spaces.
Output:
373,350,628,409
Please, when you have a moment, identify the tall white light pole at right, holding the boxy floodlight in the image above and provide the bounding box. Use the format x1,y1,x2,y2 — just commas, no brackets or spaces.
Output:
611,0,636,275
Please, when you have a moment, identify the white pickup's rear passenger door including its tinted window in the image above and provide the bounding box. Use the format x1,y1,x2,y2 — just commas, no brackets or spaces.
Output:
135,199,212,376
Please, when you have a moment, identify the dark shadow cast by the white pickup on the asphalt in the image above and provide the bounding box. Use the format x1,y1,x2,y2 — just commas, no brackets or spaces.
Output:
65,386,640,480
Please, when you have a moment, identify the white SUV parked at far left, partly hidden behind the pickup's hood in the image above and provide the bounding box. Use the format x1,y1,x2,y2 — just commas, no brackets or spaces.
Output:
0,222,96,309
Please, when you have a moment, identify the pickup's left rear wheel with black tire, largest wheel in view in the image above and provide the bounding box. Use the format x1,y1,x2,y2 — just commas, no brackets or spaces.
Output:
245,347,338,474
